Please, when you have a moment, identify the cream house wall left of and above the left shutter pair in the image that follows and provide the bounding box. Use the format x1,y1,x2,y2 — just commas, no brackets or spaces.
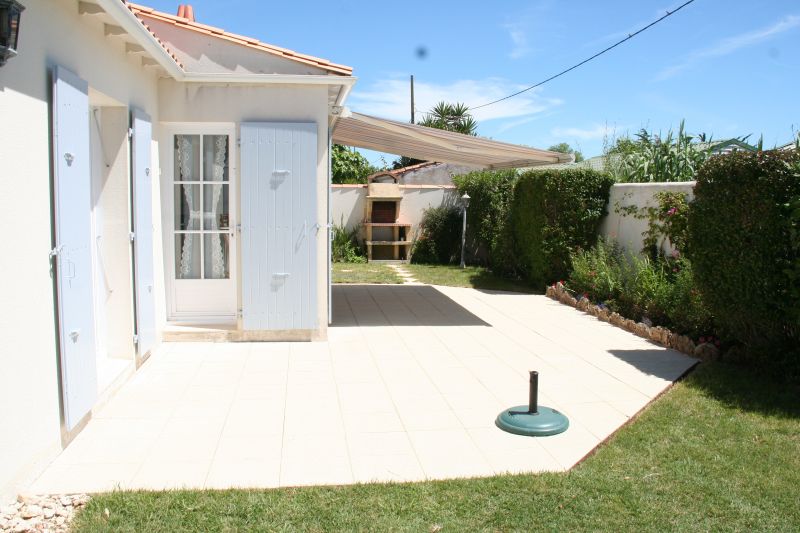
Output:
0,0,160,501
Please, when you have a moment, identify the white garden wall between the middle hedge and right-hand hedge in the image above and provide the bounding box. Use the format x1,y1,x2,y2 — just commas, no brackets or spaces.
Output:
600,181,695,254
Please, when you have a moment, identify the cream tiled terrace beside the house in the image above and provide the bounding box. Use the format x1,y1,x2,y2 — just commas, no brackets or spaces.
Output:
29,285,695,493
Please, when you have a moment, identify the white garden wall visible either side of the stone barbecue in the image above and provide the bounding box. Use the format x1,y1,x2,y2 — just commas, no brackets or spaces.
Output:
331,184,458,238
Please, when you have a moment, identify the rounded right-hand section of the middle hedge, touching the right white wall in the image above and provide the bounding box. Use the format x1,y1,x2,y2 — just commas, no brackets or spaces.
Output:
509,169,613,287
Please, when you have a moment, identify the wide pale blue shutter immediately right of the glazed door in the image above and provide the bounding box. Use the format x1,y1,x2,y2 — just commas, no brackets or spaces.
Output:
241,122,320,330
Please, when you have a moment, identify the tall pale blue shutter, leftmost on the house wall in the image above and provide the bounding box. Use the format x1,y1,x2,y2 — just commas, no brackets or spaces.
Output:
53,67,97,430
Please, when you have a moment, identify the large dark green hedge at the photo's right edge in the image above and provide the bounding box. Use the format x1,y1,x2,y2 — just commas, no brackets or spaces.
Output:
688,151,800,364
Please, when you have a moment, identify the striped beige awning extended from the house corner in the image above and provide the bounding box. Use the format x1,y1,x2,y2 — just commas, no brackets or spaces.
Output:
333,109,572,169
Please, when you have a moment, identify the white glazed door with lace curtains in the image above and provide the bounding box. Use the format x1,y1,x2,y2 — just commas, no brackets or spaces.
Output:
169,127,237,320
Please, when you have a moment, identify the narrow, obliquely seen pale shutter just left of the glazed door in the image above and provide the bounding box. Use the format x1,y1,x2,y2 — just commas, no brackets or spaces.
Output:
131,109,156,358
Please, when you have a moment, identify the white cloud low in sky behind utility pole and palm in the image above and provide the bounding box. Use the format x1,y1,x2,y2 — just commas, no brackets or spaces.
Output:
348,78,562,122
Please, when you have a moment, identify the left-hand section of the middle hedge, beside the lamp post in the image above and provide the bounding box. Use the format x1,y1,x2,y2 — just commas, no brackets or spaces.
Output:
453,170,517,274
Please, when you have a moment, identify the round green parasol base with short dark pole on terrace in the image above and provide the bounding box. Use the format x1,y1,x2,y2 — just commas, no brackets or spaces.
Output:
495,370,569,437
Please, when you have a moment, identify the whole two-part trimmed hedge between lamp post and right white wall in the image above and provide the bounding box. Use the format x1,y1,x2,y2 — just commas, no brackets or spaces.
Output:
453,169,613,290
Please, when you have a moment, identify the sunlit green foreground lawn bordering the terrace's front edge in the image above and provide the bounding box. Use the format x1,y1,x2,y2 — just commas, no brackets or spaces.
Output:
74,363,800,532
